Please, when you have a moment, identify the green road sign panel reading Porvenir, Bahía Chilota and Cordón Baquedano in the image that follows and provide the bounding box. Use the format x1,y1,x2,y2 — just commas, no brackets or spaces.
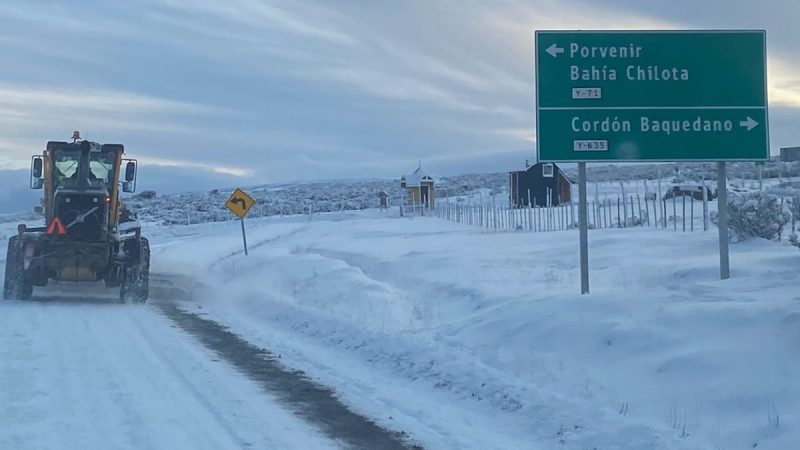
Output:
535,31,769,162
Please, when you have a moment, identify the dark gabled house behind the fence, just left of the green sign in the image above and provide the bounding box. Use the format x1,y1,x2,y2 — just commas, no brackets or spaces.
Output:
508,163,572,208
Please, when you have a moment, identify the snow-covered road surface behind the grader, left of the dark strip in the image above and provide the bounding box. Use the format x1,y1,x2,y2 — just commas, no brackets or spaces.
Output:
0,296,337,449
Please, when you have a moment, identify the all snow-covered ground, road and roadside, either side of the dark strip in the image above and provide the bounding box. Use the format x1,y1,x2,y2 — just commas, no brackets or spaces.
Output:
0,198,800,450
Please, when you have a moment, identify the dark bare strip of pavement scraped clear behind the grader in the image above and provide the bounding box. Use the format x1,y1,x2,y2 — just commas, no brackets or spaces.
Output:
156,302,422,450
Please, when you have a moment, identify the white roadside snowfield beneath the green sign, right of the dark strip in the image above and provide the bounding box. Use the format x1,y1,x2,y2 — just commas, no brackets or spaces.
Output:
148,211,800,450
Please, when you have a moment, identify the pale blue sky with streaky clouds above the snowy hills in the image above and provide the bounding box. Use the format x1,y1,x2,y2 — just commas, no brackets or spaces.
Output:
0,0,800,200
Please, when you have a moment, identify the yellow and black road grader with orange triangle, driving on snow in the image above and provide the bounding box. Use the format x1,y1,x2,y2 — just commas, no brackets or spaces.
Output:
3,131,150,302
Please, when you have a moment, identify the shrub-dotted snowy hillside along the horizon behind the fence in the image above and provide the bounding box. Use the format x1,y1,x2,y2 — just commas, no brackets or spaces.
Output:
129,162,800,224
